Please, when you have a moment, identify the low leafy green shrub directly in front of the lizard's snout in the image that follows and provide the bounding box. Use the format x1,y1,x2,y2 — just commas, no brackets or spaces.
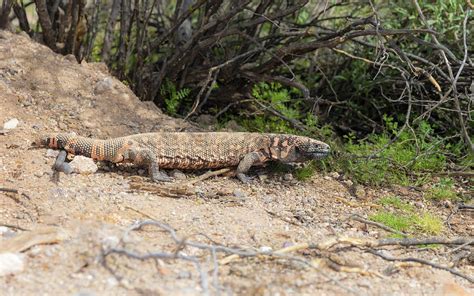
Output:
336,116,449,186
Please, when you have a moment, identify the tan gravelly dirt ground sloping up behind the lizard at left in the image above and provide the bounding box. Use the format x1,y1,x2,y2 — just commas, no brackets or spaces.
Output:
0,32,474,295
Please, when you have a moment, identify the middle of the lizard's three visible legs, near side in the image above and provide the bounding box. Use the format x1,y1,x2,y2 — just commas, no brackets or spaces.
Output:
123,148,171,182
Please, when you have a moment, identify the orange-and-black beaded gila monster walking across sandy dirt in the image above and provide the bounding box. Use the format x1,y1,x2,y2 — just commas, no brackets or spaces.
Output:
35,132,330,182
